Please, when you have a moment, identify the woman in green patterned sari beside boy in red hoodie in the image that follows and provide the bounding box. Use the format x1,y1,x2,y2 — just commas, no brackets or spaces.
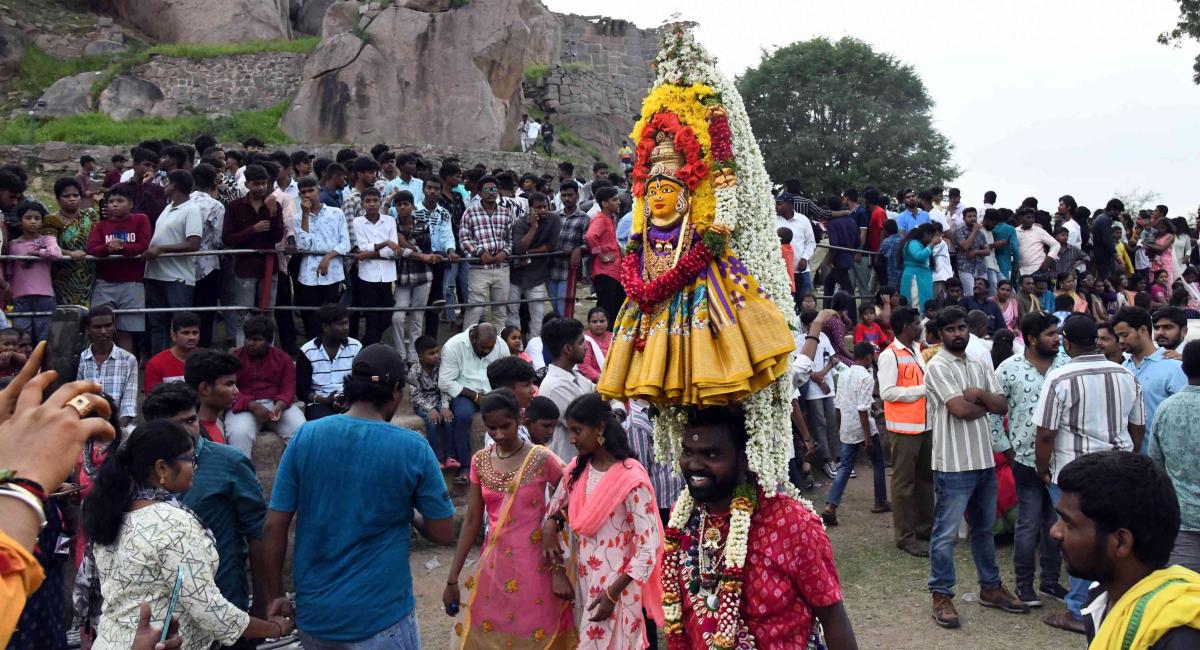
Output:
42,177,100,307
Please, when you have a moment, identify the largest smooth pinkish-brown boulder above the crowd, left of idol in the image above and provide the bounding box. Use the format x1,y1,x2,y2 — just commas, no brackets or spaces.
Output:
281,0,559,149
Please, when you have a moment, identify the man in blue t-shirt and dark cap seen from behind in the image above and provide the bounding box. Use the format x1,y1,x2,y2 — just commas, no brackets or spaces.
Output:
264,343,455,649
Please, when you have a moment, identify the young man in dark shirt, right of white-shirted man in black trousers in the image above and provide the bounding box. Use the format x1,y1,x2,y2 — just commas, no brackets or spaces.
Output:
391,189,442,363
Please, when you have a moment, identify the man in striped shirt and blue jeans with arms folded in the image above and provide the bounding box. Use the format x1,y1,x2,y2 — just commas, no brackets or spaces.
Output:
925,307,1030,627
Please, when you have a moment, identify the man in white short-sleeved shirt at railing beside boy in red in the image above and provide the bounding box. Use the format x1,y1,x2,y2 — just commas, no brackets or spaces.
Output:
142,169,204,350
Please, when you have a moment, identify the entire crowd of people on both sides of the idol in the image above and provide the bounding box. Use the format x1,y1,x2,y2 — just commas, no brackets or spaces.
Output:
0,131,1200,650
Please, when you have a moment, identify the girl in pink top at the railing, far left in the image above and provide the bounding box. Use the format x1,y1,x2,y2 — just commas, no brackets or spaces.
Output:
5,201,62,342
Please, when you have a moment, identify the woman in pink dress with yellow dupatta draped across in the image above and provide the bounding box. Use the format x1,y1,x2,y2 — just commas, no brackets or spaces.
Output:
451,389,576,650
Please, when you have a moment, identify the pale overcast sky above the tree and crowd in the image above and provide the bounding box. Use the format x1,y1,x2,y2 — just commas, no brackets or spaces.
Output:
544,0,1200,215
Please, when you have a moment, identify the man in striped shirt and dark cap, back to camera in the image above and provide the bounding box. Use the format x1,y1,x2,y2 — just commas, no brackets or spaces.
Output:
1033,314,1146,634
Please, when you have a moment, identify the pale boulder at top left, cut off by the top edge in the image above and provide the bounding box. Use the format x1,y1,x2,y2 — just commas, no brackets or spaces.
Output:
109,0,292,43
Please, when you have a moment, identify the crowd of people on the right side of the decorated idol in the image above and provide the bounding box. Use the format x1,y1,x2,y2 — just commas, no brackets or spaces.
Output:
776,187,1200,648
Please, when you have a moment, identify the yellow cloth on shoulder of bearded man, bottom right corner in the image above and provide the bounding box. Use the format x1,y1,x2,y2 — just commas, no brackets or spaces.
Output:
1088,566,1200,650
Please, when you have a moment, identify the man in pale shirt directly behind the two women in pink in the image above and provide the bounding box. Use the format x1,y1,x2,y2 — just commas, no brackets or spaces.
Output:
539,318,595,463
